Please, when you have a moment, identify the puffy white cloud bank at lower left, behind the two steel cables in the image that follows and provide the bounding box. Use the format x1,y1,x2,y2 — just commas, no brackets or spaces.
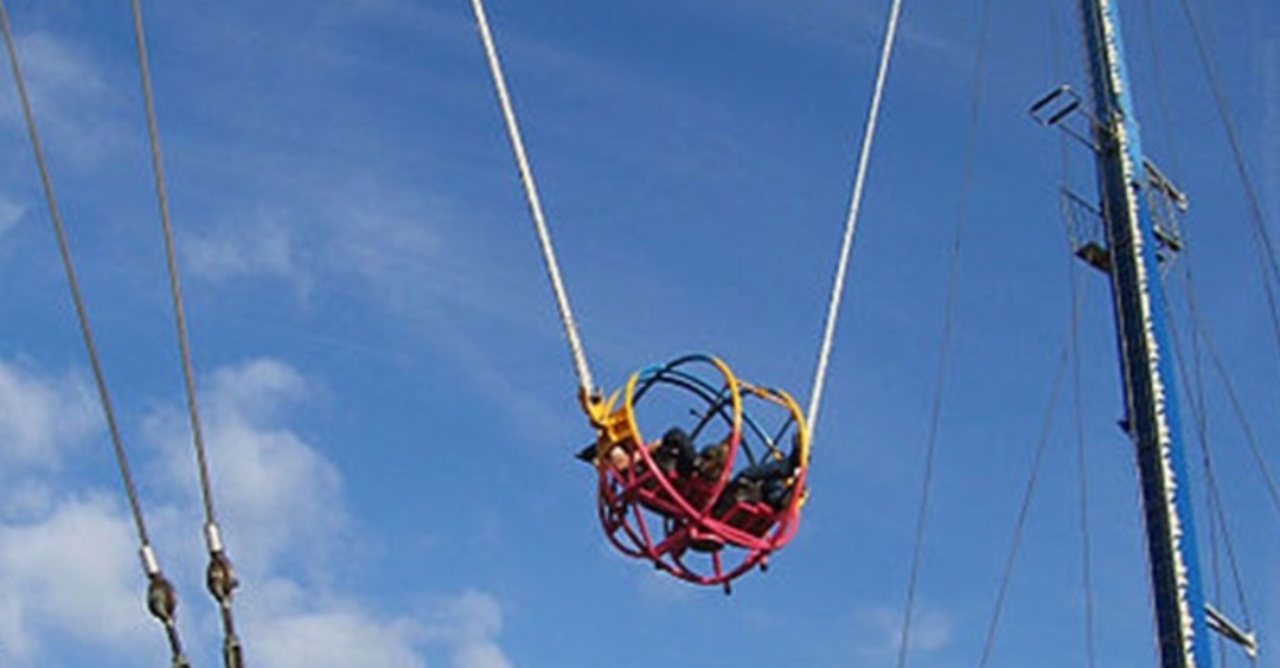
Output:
0,360,513,668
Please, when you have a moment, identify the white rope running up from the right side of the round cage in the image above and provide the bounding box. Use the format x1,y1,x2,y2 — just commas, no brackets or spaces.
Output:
805,0,902,438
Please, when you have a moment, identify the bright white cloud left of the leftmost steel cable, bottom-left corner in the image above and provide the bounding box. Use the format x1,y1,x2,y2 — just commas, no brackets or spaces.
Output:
0,361,151,667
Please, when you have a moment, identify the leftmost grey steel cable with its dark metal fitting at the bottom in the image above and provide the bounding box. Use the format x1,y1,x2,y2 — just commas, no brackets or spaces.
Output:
0,0,191,668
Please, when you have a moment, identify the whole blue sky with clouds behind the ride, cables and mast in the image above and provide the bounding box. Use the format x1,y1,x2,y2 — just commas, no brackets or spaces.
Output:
0,0,1280,668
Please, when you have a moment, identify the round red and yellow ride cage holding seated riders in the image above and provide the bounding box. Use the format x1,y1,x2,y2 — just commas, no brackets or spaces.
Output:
586,354,809,590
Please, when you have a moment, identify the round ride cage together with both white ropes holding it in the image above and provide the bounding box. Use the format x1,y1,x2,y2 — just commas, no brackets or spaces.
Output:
471,0,880,590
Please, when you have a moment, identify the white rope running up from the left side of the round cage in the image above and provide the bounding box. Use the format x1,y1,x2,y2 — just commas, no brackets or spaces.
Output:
471,0,595,395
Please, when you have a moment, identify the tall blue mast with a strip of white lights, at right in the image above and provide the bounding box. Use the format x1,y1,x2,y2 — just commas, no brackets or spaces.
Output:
1080,0,1212,668
